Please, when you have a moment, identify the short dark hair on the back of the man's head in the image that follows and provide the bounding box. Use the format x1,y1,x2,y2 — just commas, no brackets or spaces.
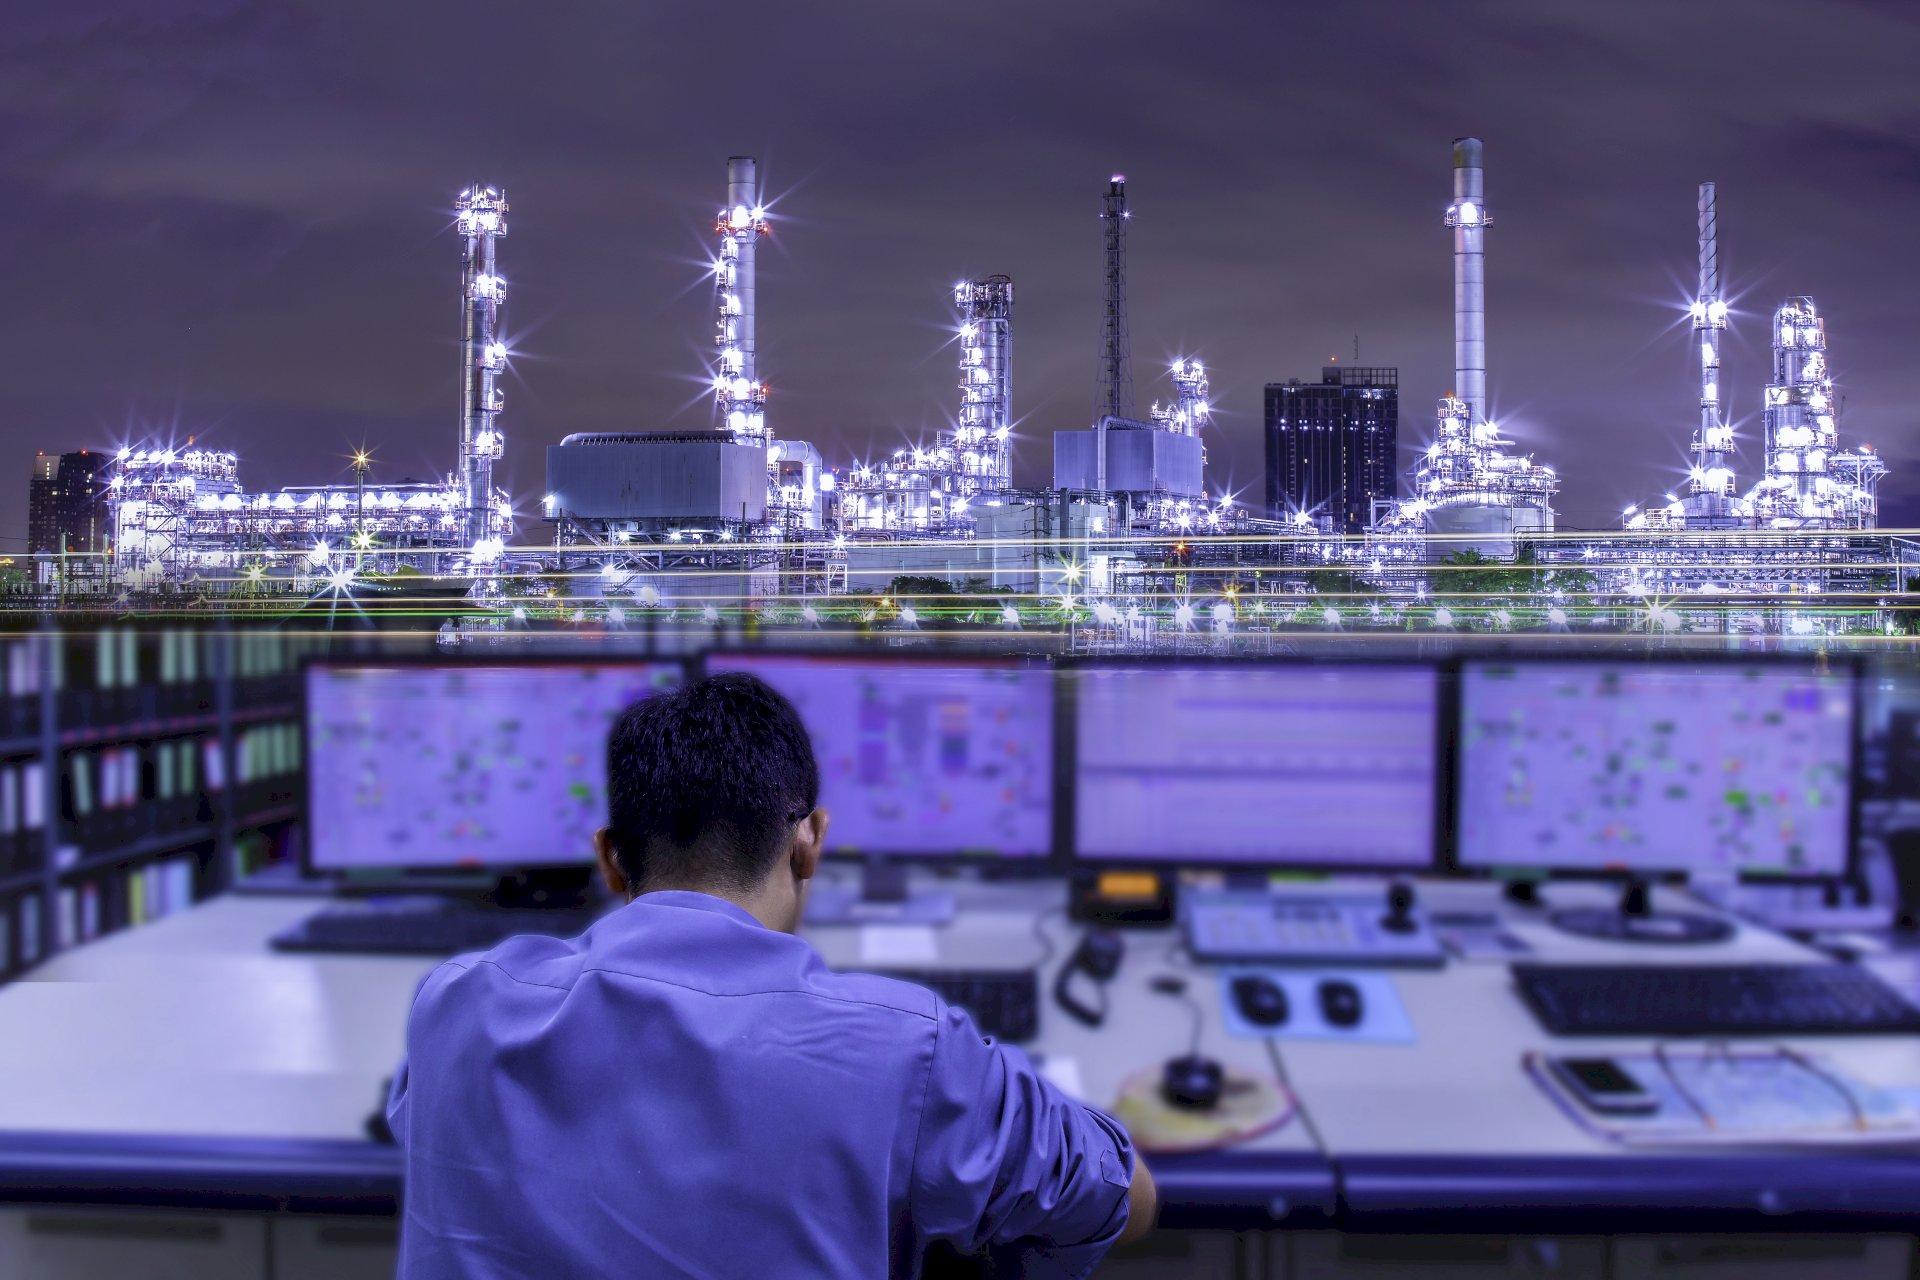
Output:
607,674,820,890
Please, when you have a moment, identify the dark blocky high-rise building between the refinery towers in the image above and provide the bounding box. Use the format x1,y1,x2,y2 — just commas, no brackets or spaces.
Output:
1267,365,1400,533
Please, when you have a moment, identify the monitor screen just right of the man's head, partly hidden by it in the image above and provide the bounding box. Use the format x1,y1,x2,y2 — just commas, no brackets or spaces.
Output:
707,652,1054,858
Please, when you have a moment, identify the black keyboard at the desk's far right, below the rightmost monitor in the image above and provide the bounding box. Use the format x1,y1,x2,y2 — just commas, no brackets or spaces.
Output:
1513,963,1920,1036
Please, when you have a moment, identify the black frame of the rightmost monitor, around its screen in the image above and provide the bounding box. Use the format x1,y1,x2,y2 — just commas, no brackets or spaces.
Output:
1448,652,1864,885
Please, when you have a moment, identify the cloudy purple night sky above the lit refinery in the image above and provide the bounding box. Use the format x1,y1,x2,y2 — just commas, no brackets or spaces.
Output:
0,0,1920,549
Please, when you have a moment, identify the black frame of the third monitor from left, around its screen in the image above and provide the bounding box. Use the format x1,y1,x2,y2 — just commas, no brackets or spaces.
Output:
1056,654,1453,879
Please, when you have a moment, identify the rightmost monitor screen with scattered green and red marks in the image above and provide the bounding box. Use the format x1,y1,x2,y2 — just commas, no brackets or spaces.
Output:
1459,662,1855,877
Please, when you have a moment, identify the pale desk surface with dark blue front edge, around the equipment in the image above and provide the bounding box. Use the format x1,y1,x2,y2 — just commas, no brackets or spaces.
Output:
11,883,1920,1230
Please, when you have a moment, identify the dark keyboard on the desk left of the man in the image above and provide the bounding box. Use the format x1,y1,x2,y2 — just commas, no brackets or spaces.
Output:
273,900,595,956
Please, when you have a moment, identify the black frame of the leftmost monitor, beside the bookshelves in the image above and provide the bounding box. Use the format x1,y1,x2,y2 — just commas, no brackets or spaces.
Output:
300,652,697,889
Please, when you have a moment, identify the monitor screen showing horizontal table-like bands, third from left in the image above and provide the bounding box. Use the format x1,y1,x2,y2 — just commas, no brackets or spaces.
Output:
1073,662,1440,867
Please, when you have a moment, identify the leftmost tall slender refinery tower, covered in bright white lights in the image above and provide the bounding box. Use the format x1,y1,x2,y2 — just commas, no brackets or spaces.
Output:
453,186,507,558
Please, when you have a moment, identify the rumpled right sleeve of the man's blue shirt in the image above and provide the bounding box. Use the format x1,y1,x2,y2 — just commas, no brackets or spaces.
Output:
910,1006,1133,1276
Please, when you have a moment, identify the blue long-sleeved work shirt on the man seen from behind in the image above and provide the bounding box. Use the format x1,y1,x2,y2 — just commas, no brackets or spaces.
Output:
388,892,1133,1280
